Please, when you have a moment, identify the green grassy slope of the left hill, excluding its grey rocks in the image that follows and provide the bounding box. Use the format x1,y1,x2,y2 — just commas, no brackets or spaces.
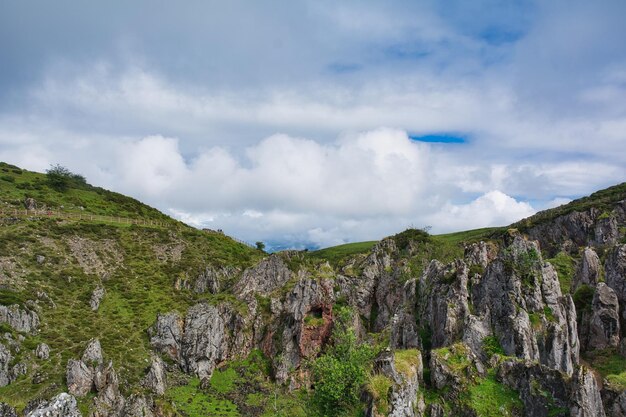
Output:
0,163,263,408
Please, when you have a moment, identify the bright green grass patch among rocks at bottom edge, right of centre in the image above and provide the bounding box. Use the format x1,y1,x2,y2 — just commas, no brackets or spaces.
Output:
469,372,524,417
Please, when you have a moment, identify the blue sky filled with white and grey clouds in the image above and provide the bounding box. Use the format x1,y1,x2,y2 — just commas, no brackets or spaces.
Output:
0,0,626,250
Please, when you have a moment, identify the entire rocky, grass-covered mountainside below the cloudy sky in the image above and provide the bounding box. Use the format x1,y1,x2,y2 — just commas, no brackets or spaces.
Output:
0,163,626,417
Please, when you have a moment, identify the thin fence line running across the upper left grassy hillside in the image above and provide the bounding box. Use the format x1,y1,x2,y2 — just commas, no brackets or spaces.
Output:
0,209,256,249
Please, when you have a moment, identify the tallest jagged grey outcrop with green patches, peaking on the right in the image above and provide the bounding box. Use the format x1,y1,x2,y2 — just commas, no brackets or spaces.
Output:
468,235,579,374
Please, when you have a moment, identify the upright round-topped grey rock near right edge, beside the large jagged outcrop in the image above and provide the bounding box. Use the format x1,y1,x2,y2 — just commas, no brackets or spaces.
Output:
587,282,620,349
